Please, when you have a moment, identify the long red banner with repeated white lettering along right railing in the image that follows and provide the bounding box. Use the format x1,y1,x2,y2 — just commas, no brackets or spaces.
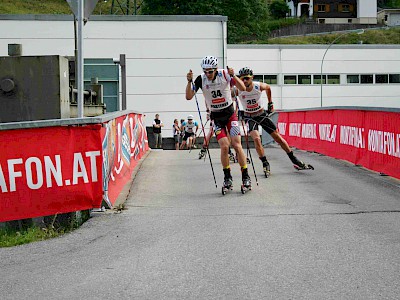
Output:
278,110,400,179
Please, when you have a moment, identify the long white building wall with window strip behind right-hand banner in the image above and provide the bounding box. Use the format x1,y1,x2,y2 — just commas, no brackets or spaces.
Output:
228,44,400,109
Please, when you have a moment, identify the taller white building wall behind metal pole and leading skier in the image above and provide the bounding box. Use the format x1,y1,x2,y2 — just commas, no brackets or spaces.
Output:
0,15,227,136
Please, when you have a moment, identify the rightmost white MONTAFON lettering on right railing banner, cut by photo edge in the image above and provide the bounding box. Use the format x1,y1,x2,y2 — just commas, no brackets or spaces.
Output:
368,130,400,157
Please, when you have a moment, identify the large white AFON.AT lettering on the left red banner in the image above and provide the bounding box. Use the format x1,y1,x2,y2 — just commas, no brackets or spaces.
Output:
0,151,101,193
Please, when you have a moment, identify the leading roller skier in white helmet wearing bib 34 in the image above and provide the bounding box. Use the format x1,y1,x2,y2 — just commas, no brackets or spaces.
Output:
186,56,251,189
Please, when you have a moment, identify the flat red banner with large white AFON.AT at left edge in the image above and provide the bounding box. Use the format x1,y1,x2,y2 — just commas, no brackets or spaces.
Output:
0,125,102,222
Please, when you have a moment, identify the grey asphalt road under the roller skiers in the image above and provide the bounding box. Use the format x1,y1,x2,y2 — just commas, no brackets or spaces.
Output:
0,146,400,300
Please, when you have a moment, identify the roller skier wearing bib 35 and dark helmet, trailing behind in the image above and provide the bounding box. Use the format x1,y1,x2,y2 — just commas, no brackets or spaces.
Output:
236,67,312,173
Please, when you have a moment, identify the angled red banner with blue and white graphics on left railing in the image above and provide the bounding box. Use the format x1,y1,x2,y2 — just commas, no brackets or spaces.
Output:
102,114,149,207
